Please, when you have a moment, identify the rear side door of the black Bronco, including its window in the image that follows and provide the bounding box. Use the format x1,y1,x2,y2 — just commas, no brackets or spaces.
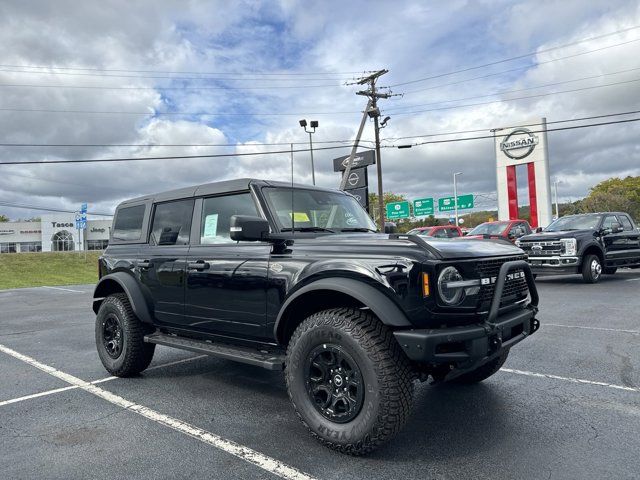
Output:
136,198,194,326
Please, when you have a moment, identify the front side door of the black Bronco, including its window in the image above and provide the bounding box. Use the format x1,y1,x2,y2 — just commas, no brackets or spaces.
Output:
185,192,271,339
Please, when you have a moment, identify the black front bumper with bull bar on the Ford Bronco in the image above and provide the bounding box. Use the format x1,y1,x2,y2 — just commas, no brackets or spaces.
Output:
393,260,540,369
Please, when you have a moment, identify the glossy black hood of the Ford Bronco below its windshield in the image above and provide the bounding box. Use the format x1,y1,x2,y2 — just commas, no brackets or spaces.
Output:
293,233,524,259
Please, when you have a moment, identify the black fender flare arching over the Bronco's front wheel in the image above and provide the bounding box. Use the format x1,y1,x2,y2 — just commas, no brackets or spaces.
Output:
273,277,413,339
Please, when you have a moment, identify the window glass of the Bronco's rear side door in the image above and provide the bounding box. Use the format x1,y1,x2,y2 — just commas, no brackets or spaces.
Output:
149,199,193,245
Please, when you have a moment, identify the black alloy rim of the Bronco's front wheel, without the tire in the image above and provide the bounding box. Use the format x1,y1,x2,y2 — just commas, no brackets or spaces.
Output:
306,344,364,423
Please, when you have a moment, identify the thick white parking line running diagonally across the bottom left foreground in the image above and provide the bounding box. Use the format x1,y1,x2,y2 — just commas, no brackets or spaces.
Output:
0,344,315,480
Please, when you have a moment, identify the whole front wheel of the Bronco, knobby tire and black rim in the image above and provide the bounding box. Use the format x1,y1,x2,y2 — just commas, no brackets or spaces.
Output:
285,308,414,455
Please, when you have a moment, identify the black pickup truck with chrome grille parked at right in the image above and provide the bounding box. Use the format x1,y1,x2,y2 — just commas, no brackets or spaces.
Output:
516,212,640,283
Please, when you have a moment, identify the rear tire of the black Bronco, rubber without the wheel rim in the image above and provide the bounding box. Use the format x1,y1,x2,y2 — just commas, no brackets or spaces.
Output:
95,293,155,377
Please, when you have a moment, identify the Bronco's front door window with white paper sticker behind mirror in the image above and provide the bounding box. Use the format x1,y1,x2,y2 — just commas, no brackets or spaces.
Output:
200,193,258,245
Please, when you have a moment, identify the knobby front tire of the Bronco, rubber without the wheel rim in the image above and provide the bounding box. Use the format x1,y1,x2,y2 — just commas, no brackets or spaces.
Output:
285,308,415,455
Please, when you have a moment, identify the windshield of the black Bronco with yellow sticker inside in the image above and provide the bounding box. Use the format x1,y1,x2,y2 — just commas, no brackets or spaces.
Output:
262,187,376,232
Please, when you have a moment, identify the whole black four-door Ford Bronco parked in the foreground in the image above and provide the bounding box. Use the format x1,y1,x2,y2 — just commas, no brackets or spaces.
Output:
93,179,539,454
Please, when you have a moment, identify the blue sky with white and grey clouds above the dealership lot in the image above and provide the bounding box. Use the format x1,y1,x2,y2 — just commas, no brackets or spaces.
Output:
0,0,640,218
